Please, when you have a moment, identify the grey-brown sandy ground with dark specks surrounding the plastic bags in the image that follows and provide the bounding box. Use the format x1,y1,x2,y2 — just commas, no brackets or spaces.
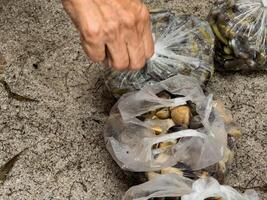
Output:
0,0,267,200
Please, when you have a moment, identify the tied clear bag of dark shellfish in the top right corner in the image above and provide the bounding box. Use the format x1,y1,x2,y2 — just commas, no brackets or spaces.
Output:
209,0,267,71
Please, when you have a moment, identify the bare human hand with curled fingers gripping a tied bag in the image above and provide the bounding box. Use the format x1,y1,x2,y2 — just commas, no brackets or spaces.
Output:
62,0,154,70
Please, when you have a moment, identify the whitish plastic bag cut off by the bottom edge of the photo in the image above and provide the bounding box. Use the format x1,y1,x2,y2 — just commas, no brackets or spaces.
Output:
123,174,259,200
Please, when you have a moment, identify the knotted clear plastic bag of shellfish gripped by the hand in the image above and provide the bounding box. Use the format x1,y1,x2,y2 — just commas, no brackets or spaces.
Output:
107,12,214,97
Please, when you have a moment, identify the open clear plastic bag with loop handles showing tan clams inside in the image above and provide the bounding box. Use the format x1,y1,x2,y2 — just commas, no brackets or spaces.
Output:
104,75,227,172
